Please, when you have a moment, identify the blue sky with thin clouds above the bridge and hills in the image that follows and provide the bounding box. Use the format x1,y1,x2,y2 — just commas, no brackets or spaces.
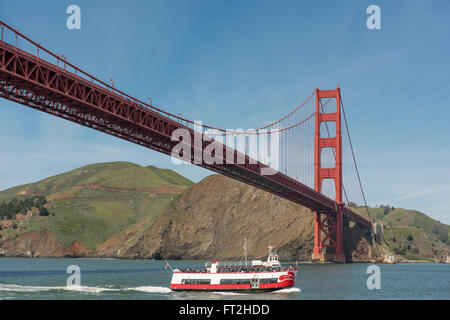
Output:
0,0,450,224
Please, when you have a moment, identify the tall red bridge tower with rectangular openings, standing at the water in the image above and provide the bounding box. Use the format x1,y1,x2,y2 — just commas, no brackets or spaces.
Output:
312,86,345,263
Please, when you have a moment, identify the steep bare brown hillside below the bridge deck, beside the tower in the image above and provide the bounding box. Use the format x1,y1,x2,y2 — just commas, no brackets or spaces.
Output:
94,175,371,261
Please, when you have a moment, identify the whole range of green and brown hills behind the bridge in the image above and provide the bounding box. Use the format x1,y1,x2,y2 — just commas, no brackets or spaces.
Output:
0,162,450,261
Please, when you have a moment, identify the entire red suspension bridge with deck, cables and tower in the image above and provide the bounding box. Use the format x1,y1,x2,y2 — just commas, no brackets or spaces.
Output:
0,21,371,262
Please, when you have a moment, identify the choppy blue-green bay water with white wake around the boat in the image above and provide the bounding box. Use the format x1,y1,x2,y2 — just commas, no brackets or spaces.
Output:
0,258,450,300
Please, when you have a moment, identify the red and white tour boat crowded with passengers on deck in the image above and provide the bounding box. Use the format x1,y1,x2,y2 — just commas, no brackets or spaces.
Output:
170,247,298,292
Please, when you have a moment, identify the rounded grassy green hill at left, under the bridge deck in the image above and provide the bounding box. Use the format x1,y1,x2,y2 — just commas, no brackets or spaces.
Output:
0,162,193,249
